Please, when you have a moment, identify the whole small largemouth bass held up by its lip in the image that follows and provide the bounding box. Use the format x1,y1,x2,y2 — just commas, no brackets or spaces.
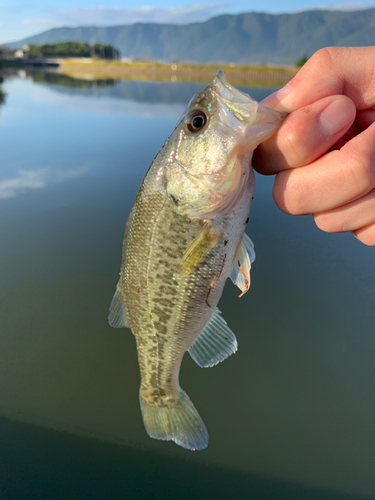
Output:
108,70,284,450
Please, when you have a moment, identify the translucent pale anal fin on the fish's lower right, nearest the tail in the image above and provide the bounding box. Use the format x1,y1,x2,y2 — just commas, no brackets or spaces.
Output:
189,308,238,368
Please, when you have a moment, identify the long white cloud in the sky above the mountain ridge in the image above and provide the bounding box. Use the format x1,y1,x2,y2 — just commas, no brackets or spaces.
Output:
31,2,229,26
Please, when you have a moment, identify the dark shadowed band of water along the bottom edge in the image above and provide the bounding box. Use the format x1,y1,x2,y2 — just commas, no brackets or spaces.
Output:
0,418,370,500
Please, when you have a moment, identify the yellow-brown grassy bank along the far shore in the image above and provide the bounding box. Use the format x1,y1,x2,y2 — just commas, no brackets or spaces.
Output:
60,59,297,86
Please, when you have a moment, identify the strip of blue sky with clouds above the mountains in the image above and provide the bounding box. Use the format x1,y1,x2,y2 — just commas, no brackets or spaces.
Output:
0,0,375,43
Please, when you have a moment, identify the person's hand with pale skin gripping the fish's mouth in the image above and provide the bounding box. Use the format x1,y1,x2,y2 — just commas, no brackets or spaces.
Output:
253,47,375,246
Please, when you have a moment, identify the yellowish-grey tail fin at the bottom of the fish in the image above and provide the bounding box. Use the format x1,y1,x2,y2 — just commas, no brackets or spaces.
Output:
139,389,208,450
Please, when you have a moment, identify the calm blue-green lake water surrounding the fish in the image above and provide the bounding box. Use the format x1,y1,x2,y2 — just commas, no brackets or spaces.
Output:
0,74,375,500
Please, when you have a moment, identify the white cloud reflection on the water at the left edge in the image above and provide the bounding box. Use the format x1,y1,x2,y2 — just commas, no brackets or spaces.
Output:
0,168,87,199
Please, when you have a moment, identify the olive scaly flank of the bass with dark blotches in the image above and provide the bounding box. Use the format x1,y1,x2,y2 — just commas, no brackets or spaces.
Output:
121,164,229,402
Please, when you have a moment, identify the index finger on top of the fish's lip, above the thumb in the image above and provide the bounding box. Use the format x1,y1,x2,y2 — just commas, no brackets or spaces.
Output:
262,47,375,112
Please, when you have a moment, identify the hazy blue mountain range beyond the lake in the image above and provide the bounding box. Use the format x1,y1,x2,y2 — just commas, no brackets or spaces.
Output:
7,9,375,65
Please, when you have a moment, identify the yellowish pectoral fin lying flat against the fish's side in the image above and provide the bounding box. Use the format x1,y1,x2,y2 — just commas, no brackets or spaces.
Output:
180,222,222,277
